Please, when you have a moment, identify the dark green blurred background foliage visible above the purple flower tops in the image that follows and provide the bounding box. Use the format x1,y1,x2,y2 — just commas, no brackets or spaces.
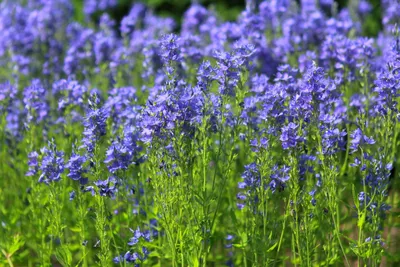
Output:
73,0,382,36
